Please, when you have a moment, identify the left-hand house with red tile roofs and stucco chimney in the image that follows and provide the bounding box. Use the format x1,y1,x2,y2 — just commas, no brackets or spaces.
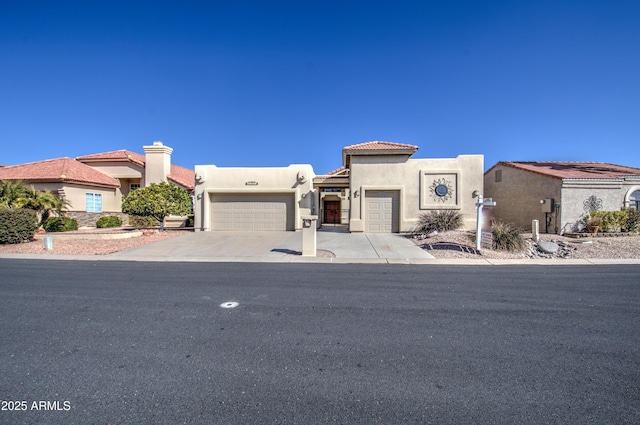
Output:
0,142,194,226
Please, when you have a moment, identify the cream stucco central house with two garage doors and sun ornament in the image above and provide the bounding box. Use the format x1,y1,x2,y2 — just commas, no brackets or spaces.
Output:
195,142,483,232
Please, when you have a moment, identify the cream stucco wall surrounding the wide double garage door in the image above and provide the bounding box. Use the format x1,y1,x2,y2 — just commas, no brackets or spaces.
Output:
195,164,319,231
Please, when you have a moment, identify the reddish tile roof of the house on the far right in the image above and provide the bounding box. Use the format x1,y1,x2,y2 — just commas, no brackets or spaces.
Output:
498,161,640,179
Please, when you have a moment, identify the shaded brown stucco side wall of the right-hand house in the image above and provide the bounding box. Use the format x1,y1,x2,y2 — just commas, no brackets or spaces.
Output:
483,165,562,233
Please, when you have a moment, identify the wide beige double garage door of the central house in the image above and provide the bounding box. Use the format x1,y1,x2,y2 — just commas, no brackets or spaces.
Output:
211,193,295,230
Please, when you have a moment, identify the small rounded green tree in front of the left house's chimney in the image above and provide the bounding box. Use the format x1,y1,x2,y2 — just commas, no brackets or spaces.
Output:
122,182,193,230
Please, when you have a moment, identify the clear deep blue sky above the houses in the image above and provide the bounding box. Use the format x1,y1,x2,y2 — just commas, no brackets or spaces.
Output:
0,0,640,174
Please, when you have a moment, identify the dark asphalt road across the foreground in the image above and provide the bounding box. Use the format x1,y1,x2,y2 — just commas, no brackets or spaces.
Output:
0,260,640,425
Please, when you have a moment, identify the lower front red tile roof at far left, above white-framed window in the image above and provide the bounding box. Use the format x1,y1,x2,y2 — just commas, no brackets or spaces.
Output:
0,158,120,188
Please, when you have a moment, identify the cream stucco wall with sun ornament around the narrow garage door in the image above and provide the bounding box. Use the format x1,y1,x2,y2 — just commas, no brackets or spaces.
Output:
350,155,484,233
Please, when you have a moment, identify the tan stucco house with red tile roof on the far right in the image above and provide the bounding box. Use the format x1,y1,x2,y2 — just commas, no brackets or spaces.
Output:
484,162,640,233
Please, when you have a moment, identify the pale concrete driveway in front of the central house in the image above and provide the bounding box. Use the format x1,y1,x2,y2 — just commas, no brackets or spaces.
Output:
109,230,434,261
